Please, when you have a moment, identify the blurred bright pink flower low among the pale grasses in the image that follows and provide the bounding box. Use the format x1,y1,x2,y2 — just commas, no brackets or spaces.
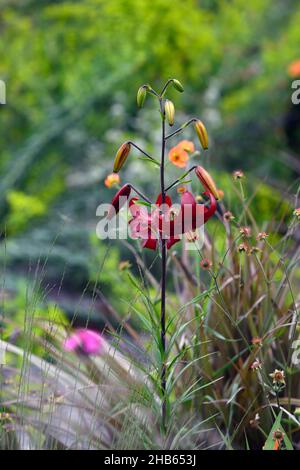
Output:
64,329,103,355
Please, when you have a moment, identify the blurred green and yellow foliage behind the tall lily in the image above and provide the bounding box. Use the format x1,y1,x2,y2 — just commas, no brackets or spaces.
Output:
0,0,300,325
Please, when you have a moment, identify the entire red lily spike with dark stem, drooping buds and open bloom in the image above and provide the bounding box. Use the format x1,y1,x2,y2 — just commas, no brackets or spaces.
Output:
107,79,219,433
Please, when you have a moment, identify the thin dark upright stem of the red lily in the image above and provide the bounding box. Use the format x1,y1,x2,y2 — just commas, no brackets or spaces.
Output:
160,99,167,432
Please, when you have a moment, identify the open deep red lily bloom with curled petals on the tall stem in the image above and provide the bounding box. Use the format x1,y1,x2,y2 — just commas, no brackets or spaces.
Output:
129,191,217,250
